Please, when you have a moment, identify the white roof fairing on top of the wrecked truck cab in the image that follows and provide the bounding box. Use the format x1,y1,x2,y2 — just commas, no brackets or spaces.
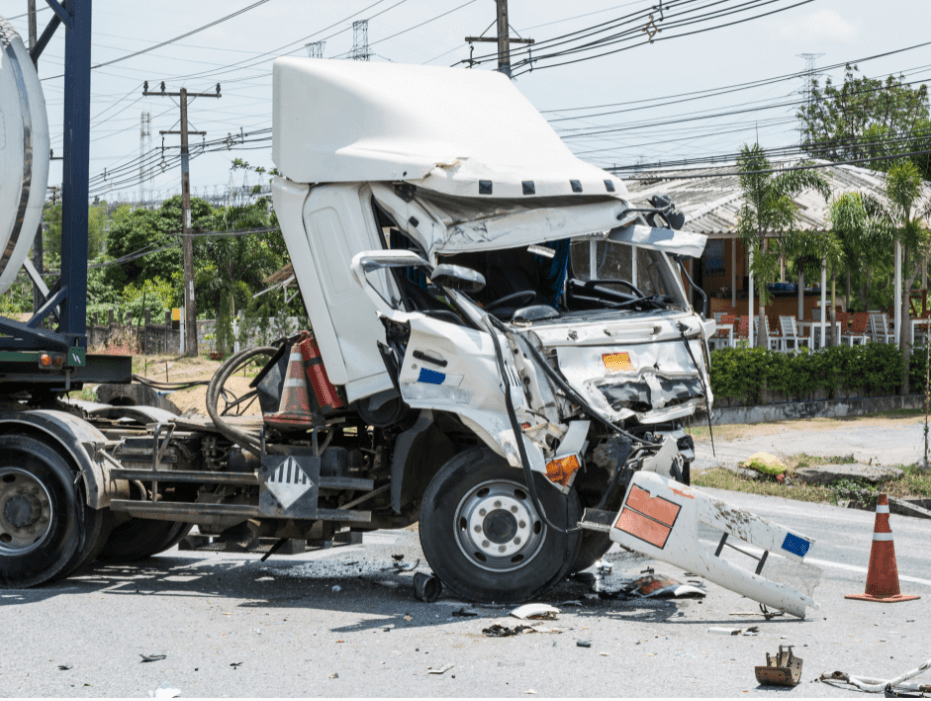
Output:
272,58,626,200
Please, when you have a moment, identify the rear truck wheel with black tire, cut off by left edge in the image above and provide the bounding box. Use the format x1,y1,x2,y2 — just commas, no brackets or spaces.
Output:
0,435,93,588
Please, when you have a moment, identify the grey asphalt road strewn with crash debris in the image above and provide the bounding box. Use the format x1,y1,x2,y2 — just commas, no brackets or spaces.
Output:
0,490,931,697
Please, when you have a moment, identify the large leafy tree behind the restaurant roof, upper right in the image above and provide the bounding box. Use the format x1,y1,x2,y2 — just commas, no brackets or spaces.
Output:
798,64,931,179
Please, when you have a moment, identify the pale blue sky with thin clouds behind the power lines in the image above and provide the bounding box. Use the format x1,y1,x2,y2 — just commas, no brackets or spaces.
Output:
0,0,931,202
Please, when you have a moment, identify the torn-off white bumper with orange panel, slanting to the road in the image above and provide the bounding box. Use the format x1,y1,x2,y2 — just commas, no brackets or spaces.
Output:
581,472,821,618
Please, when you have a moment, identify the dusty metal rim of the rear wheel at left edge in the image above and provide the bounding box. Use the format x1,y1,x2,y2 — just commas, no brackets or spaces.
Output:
0,467,52,555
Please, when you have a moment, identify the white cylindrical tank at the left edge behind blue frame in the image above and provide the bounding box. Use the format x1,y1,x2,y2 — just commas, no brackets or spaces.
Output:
0,17,50,294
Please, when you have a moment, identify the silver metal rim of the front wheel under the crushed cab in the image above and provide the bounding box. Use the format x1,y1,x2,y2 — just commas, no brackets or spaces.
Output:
453,480,546,572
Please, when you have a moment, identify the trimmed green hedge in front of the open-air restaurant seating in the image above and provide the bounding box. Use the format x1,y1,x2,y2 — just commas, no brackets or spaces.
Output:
711,343,925,405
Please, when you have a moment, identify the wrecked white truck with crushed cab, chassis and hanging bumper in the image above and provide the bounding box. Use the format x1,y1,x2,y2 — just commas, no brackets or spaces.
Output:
0,49,817,616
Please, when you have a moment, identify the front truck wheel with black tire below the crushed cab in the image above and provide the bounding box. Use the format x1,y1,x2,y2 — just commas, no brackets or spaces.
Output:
420,447,582,604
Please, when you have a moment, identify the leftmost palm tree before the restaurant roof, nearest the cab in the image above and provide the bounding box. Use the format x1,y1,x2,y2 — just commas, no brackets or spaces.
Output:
737,144,835,346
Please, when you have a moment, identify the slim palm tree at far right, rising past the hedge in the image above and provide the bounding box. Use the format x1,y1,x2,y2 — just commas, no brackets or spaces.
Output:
886,160,931,394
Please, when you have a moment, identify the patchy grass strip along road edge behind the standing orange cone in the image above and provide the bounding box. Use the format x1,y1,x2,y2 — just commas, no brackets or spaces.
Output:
692,453,931,507
